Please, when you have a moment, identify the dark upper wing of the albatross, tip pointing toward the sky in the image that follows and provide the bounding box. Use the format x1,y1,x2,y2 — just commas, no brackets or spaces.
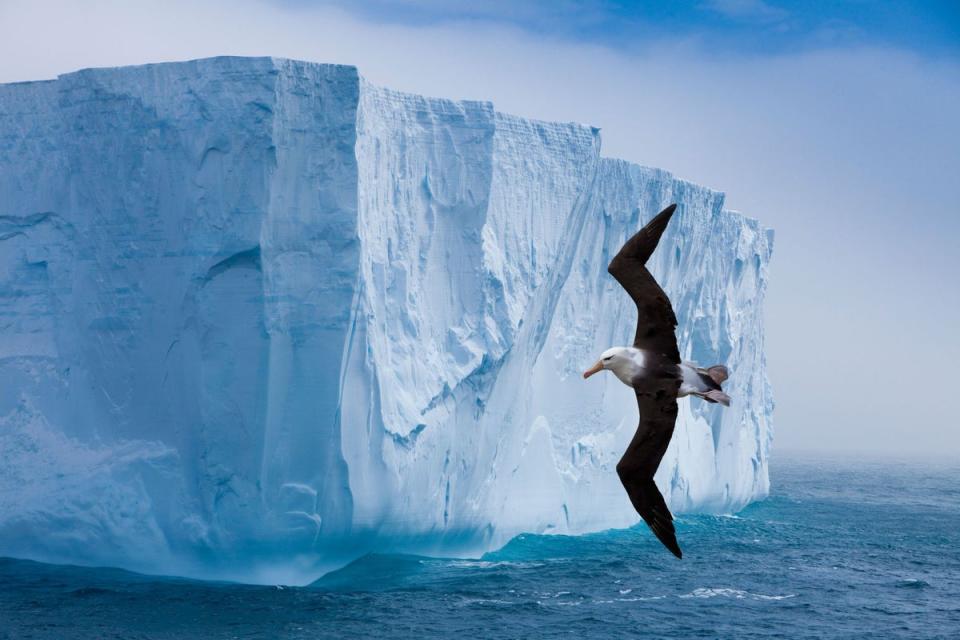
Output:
607,204,680,363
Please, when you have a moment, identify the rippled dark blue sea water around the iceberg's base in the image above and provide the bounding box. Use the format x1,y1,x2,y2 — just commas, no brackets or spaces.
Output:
0,458,960,639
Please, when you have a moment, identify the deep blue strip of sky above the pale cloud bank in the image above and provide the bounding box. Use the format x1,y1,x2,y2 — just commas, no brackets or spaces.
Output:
288,0,960,54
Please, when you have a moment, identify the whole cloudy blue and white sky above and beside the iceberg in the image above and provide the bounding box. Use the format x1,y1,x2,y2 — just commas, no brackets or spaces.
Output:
0,0,960,458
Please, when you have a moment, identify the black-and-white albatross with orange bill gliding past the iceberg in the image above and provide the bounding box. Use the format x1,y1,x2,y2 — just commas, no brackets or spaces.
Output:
583,204,730,558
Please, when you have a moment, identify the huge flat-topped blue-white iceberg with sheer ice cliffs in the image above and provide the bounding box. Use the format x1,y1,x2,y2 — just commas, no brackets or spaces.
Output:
0,58,772,582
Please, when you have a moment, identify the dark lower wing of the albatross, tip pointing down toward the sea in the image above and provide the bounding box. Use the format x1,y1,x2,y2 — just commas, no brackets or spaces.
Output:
617,367,683,558
